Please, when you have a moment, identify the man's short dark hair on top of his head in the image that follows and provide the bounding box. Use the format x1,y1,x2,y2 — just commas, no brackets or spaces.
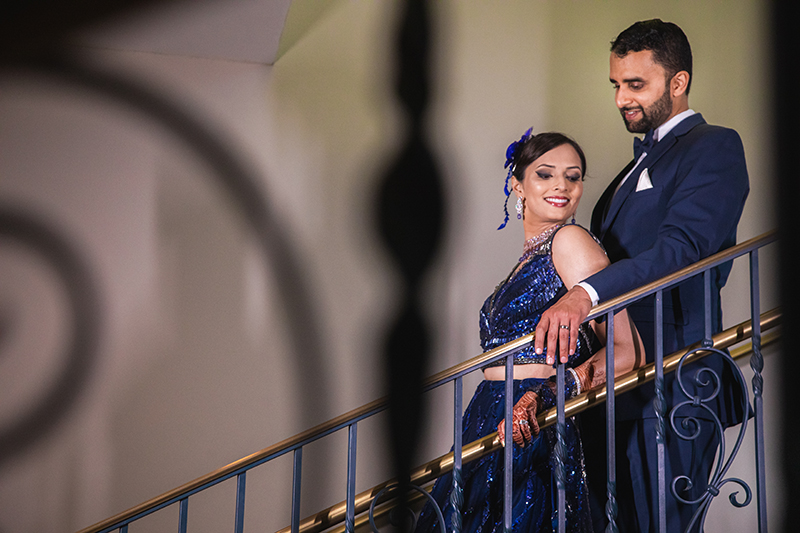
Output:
611,19,692,94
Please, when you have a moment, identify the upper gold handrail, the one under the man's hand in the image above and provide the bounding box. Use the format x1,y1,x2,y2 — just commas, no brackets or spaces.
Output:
78,230,777,533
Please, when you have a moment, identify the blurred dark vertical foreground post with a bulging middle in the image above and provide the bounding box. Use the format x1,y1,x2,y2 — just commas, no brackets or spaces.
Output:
370,0,445,531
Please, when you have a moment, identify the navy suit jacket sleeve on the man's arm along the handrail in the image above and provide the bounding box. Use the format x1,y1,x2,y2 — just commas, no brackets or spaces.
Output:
585,127,749,301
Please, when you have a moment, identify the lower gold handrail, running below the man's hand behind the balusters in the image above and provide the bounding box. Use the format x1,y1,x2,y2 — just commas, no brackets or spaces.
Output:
278,309,781,533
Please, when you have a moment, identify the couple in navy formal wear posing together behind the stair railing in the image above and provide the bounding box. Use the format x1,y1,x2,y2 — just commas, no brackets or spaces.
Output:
417,19,749,533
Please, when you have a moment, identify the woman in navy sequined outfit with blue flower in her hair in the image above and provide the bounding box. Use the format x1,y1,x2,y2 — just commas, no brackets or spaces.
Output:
417,130,641,533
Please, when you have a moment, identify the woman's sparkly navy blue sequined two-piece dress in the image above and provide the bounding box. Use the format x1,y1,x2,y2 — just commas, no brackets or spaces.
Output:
416,224,599,533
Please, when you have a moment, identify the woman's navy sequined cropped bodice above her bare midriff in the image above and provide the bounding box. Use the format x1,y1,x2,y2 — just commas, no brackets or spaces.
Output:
480,223,596,366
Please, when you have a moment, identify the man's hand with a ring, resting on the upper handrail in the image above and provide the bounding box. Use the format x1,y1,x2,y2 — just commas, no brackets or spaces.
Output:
534,285,592,365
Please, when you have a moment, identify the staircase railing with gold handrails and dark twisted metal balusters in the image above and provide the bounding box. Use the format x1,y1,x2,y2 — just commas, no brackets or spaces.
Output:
79,231,781,533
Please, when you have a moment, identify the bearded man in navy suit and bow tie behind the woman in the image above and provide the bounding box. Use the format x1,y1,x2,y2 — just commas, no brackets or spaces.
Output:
535,19,749,531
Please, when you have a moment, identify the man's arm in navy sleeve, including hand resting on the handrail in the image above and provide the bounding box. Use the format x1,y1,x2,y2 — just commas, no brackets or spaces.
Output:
534,129,748,364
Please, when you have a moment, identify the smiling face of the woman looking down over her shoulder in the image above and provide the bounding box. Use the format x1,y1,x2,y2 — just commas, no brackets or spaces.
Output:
514,144,583,231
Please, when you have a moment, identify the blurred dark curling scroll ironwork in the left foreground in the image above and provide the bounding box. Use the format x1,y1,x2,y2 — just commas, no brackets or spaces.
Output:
0,1,330,474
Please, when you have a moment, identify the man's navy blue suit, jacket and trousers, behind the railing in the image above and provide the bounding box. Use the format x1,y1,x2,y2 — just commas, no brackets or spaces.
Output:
581,114,749,531
